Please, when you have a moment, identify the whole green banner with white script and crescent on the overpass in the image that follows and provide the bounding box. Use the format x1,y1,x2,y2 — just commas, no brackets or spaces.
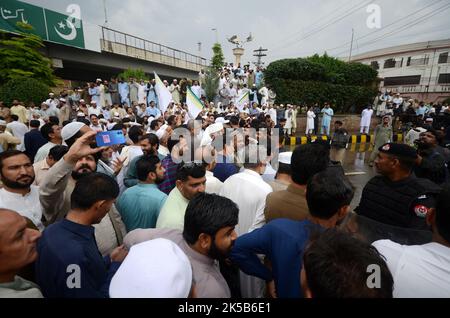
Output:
0,0,85,49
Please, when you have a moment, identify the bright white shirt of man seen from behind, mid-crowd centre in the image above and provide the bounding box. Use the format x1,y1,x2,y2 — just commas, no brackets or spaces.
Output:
220,169,272,235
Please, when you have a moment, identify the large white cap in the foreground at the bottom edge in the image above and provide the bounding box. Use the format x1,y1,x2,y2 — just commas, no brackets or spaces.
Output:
109,239,192,298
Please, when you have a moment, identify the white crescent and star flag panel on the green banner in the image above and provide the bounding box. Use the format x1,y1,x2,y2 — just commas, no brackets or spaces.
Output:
45,9,84,49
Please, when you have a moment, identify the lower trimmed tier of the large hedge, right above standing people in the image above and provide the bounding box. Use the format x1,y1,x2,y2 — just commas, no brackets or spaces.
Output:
273,79,377,113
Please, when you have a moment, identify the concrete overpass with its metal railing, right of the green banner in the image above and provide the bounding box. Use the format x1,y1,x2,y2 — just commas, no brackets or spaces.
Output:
45,27,208,81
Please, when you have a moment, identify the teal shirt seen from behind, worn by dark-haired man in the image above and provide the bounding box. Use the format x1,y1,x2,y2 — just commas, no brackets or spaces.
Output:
116,183,167,232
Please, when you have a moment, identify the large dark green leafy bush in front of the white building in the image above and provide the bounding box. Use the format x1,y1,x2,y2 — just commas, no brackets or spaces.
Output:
264,54,378,112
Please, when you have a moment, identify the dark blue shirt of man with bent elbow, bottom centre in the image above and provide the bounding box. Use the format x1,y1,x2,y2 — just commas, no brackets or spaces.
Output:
231,219,322,298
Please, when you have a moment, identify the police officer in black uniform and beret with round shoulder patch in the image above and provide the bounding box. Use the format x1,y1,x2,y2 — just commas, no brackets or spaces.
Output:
355,143,441,230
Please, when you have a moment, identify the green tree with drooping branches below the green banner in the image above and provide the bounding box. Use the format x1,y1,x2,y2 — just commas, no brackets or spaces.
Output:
0,22,57,86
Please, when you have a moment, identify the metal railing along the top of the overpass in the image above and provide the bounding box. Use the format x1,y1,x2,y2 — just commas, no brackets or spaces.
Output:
101,27,208,72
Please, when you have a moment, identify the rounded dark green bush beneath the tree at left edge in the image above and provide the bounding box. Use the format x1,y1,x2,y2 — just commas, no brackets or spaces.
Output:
0,77,50,105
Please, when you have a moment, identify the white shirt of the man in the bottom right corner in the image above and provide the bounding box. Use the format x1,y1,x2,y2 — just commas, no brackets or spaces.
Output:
373,240,450,298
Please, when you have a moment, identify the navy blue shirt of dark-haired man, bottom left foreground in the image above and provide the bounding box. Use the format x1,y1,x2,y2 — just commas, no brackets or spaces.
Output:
36,220,120,298
